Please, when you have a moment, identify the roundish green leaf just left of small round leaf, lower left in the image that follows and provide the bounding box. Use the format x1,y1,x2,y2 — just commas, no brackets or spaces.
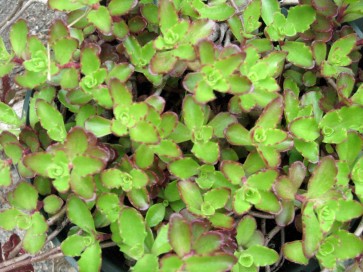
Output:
11,182,38,211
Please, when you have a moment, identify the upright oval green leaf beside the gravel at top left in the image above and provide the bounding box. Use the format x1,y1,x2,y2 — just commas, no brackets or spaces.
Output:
9,20,29,58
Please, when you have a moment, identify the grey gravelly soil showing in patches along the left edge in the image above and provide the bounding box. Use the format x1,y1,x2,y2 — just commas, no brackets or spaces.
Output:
0,0,76,272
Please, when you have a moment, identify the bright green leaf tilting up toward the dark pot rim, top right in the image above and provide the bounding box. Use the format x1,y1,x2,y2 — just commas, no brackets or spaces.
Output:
328,34,357,66
